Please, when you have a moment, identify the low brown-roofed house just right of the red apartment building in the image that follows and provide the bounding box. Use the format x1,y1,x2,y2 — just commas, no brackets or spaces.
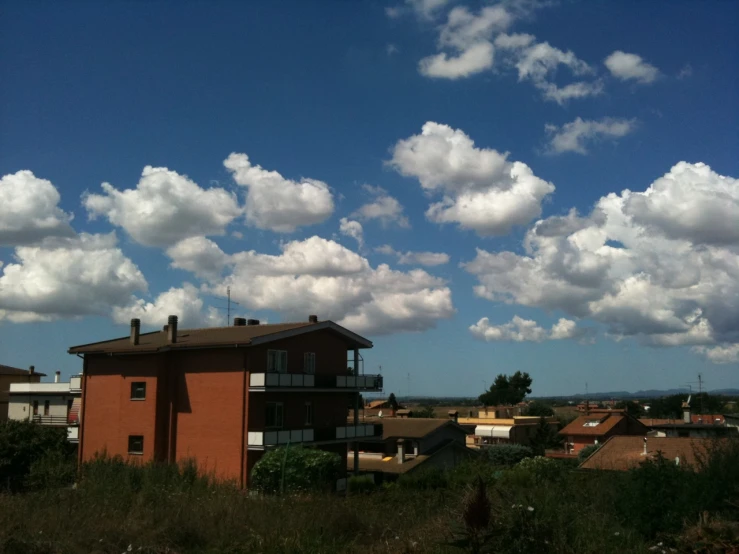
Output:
348,418,475,480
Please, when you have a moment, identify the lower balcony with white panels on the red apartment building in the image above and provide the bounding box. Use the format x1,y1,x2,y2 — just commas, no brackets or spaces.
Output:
247,424,382,450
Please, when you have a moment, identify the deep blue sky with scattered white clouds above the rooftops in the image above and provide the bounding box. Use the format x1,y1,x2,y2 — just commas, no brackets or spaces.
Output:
0,0,739,395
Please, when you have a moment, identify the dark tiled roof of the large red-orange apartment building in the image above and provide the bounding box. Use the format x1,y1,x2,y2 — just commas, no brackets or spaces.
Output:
69,321,371,354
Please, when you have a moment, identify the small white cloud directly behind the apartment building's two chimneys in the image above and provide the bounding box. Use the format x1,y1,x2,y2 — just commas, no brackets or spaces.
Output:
112,283,220,329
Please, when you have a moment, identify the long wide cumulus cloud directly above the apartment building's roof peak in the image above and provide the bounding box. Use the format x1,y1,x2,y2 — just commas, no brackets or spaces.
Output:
192,236,454,334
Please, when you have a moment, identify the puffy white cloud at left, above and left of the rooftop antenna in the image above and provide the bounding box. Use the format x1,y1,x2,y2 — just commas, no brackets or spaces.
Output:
83,166,242,246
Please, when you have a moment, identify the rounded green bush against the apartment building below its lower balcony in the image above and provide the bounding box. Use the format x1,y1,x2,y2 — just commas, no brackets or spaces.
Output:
250,447,342,492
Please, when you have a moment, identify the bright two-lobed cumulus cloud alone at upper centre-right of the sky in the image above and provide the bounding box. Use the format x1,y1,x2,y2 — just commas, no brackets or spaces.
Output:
389,121,554,236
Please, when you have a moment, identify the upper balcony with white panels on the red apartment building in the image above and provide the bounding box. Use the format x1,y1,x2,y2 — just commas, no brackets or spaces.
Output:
249,373,382,392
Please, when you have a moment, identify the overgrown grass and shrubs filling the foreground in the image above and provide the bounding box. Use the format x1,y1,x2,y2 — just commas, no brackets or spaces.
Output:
0,420,739,554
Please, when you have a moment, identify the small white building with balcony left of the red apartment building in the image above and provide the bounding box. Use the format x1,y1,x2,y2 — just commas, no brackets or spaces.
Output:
8,371,82,442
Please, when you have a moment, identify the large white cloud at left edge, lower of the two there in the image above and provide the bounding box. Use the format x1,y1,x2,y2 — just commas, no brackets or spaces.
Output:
0,233,147,322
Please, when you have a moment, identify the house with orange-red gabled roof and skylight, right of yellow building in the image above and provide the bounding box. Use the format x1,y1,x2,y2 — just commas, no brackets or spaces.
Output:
559,409,649,454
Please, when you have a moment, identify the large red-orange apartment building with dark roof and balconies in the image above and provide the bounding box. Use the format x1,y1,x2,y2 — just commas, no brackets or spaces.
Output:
69,316,382,487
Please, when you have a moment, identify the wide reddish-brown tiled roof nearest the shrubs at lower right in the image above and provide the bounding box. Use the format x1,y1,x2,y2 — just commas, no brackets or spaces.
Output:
580,435,713,471
